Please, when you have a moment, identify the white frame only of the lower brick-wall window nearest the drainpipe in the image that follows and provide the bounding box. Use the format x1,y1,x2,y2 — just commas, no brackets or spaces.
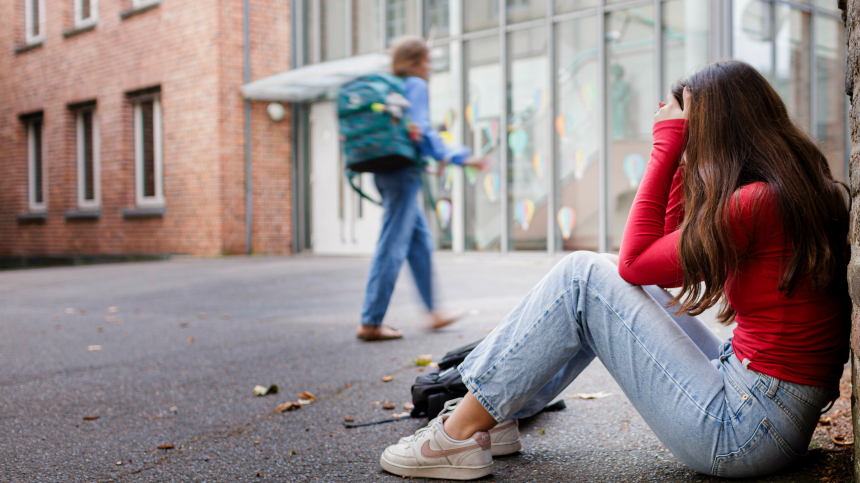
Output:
133,94,164,208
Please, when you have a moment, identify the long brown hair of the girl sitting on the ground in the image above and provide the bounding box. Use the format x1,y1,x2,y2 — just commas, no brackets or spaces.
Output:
672,61,850,324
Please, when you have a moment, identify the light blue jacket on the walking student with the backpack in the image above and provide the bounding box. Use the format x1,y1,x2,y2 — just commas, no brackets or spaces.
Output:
406,77,472,166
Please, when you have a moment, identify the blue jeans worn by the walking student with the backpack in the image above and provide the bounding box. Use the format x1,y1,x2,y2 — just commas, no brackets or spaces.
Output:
361,166,433,325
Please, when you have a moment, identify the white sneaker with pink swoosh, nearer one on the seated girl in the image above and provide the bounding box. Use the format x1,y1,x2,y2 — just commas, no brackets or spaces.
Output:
379,417,493,480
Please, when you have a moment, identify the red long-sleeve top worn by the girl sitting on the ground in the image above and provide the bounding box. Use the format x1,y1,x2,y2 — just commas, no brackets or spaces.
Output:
618,119,851,389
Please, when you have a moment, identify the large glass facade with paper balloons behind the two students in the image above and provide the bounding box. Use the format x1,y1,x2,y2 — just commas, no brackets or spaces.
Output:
300,0,848,252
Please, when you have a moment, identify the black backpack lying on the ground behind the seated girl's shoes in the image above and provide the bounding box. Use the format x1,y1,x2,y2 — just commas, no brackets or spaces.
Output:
411,339,484,418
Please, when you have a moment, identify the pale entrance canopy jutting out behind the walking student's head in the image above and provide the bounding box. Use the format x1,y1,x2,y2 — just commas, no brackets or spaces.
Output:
241,54,391,102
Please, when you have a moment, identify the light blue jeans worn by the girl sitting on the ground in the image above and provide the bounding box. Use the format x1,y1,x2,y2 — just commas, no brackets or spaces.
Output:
459,252,838,477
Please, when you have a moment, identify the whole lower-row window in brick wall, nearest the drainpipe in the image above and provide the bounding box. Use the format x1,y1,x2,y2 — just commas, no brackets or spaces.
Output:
133,94,164,207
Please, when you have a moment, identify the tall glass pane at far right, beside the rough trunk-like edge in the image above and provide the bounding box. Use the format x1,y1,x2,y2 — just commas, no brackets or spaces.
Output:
815,16,847,181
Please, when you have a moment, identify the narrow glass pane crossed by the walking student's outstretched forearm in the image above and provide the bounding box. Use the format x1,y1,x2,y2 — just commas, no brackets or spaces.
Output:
425,45,460,249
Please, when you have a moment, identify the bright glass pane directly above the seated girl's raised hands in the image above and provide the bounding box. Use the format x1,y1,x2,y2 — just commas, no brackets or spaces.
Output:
660,0,711,85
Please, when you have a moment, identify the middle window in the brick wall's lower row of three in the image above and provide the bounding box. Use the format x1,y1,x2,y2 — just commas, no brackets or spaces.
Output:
75,107,101,209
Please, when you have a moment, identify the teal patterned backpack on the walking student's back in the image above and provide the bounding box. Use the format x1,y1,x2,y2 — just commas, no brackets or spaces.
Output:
337,74,422,202
